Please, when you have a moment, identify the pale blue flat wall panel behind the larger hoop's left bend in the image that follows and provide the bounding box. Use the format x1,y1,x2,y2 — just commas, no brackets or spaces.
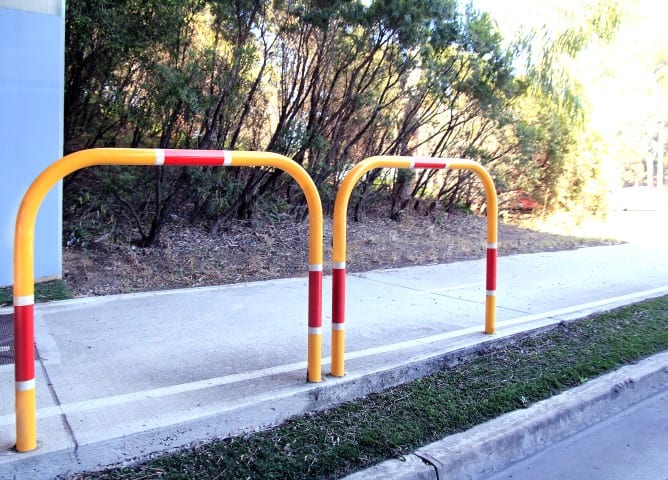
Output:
0,0,65,286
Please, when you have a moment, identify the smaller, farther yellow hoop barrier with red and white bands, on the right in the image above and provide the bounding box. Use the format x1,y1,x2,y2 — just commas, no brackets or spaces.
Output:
331,156,498,377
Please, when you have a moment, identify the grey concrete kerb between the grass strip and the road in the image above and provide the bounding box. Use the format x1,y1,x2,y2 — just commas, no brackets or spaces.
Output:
345,352,668,480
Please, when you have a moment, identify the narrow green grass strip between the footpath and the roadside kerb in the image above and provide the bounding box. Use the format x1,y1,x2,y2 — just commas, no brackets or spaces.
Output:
76,296,668,479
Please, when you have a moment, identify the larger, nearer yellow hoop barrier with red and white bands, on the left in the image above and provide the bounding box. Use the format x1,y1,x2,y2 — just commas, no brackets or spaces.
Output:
14,148,323,452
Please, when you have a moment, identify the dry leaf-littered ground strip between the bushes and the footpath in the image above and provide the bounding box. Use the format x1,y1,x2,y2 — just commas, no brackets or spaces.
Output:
63,214,610,296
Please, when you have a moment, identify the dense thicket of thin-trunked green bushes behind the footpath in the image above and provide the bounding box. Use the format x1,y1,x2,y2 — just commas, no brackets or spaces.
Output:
64,0,620,245
